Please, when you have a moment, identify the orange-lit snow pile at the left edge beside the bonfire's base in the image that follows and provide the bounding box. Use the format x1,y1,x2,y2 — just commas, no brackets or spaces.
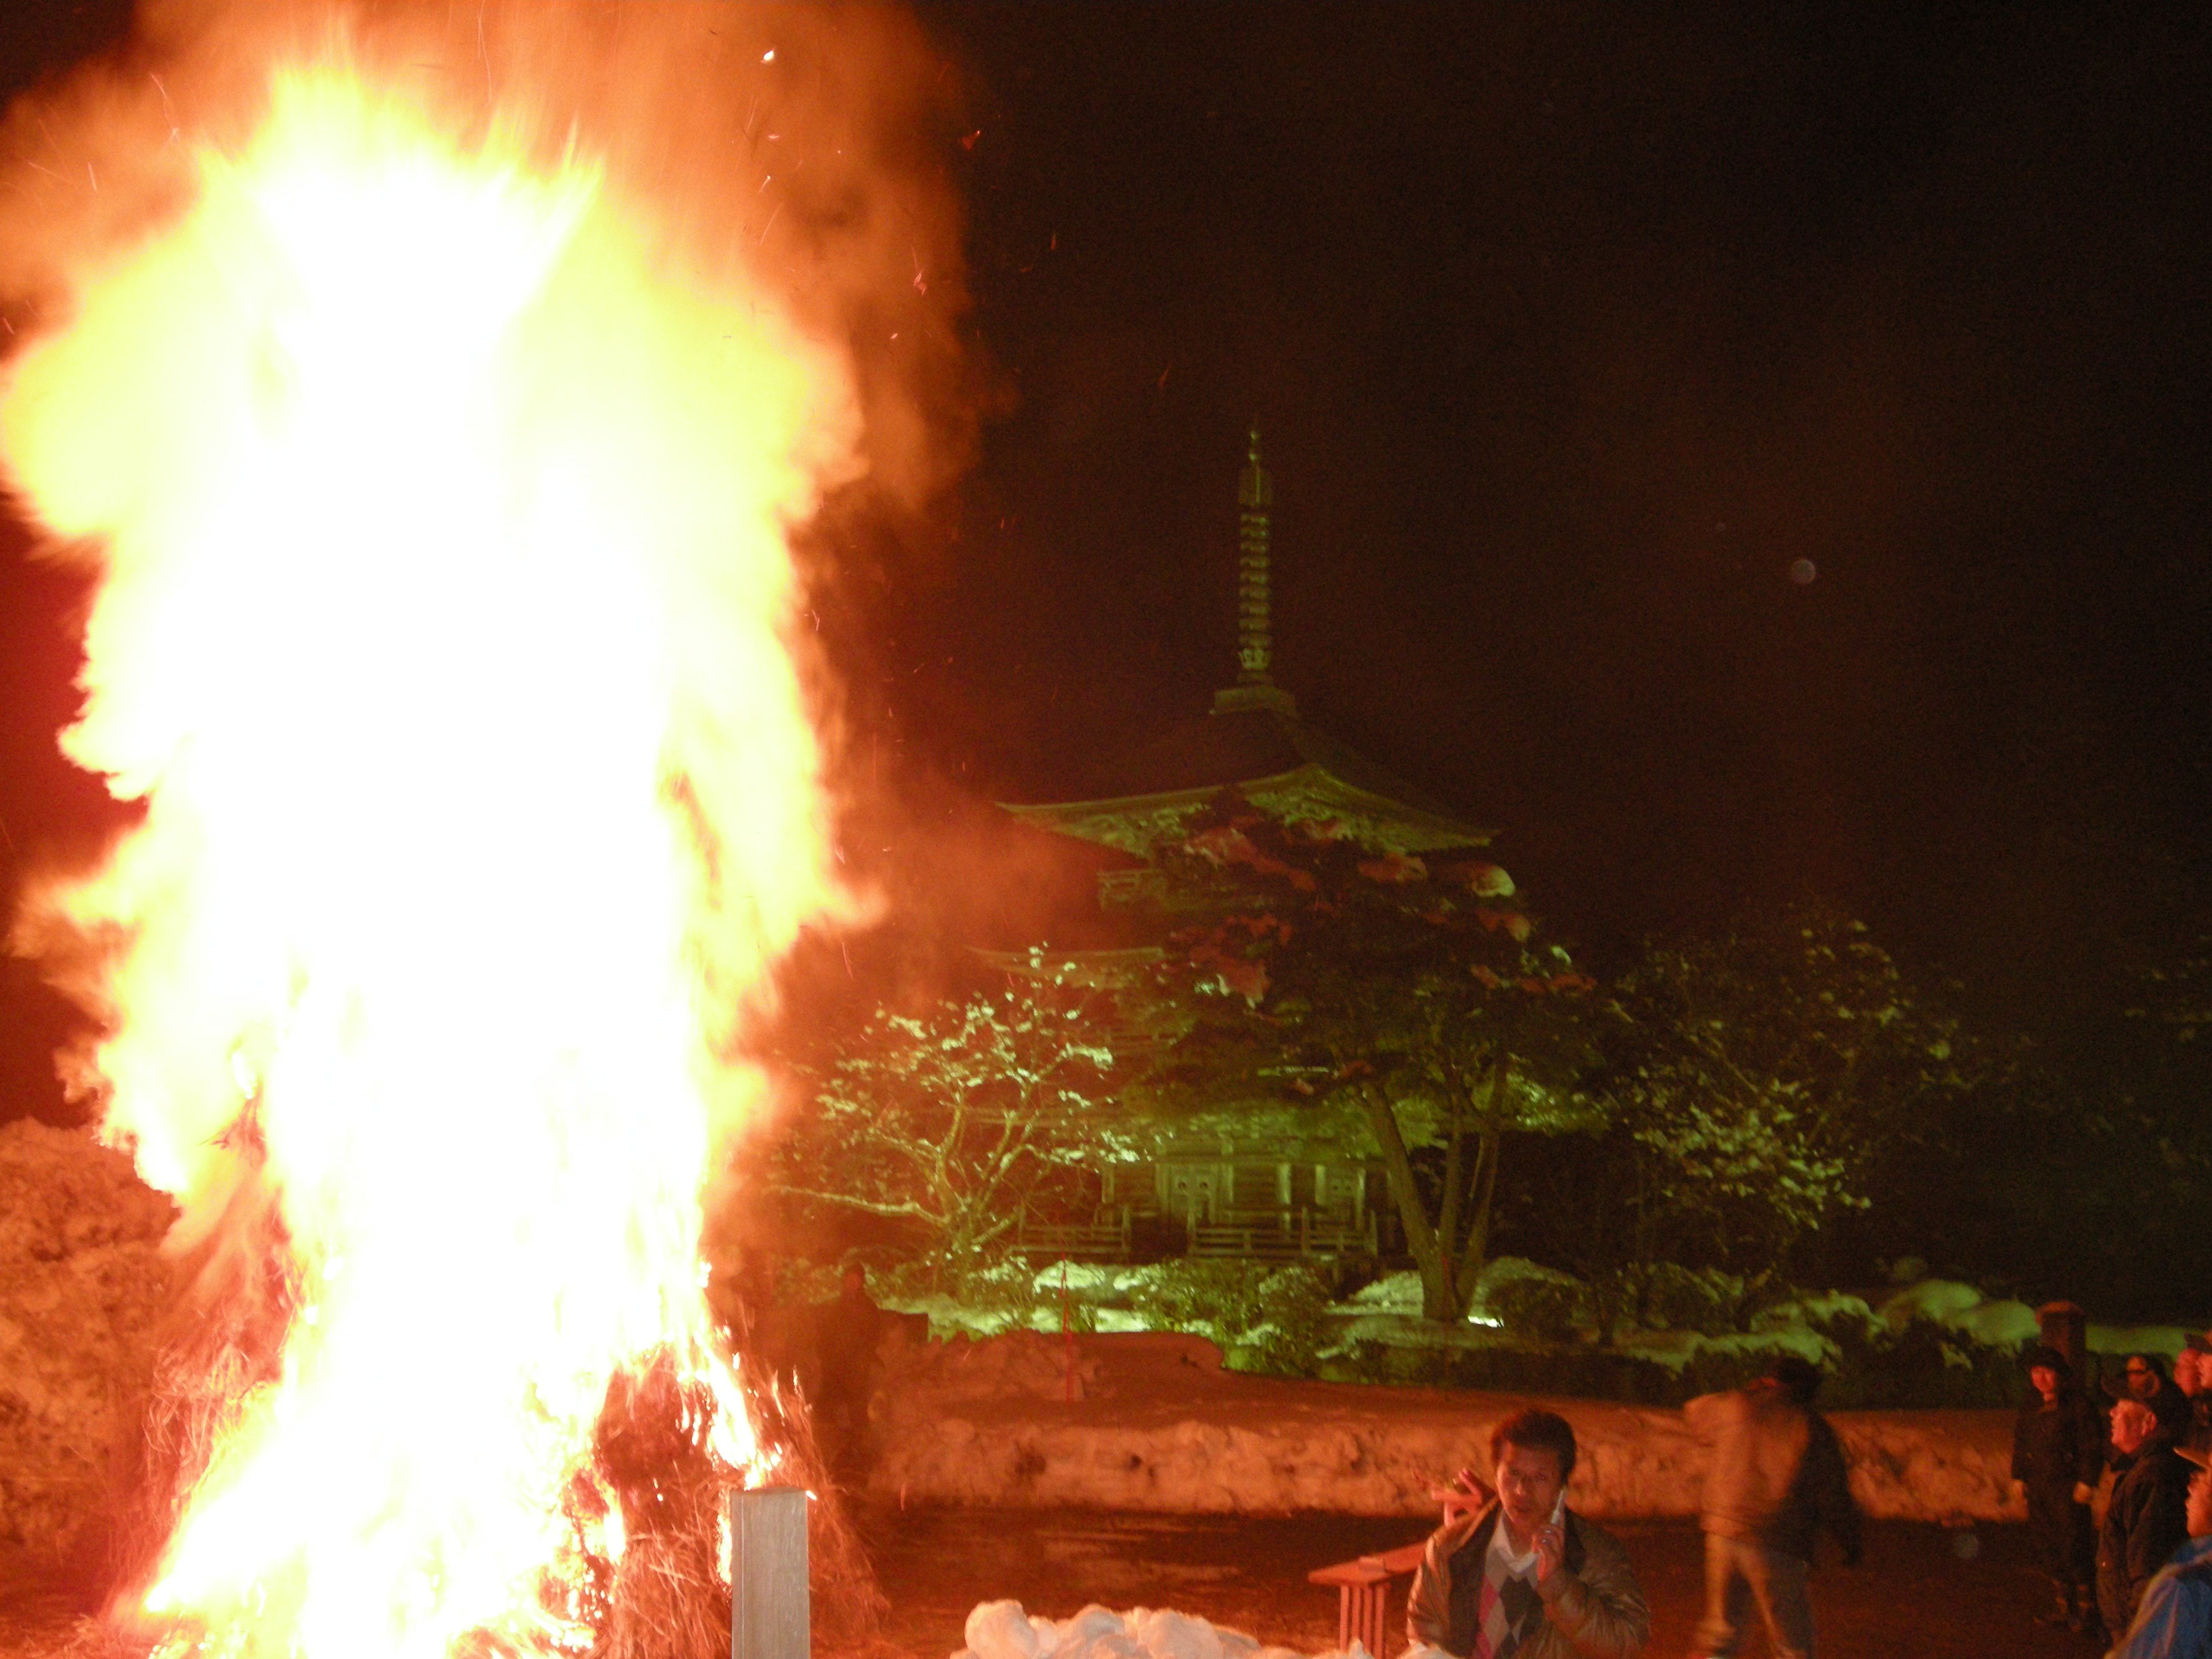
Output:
0,1119,173,1553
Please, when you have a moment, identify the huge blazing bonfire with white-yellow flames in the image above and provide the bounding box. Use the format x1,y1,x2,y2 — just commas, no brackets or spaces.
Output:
0,7,960,1659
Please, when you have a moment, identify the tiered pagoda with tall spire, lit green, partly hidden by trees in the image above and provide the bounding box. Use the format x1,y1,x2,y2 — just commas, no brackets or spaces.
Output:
1002,425,1491,1259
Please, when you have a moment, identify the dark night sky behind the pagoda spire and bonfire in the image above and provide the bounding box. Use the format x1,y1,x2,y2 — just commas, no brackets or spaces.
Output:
0,4,2212,1110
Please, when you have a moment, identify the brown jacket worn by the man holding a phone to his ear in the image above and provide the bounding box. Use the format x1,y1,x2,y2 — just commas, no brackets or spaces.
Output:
1405,1502,1652,1659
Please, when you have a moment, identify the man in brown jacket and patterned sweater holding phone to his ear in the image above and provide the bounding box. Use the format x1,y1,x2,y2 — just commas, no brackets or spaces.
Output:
1405,1411,1652,1659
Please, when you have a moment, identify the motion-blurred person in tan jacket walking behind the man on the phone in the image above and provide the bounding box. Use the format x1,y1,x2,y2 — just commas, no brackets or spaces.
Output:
1683,1354,1860,1659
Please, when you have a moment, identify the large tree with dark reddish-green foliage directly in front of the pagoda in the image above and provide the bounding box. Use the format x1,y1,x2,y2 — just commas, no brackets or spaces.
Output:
1152,792,1595,1321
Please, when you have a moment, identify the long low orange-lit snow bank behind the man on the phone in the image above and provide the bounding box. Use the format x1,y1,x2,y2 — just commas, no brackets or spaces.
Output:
872,1334,2026,1531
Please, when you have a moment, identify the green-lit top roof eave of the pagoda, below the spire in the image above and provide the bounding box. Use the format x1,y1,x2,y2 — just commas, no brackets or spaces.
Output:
1000,761,1495,856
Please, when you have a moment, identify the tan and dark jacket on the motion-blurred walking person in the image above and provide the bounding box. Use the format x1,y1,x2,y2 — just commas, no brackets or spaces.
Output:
1681,1383,1858,1562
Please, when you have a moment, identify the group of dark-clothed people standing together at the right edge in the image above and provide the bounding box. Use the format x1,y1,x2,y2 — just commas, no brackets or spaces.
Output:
2013,1336,2212,1659
